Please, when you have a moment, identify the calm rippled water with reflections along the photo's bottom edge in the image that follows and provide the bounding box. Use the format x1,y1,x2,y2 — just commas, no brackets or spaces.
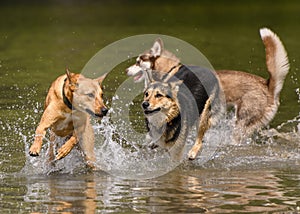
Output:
0,164,300,213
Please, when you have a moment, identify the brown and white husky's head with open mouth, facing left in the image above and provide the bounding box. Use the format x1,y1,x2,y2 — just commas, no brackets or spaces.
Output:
126,38,180,82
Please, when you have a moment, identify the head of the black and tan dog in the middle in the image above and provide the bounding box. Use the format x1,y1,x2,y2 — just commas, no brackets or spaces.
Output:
142,81,182,122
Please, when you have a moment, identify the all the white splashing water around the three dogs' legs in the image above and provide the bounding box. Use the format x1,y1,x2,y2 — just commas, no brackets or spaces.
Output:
18,83,300,179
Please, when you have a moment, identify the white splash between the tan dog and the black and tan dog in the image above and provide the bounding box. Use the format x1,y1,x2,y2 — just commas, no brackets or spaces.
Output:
94,111,184,179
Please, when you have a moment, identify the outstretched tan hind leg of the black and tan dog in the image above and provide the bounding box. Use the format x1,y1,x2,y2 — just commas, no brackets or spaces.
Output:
188,97,211,160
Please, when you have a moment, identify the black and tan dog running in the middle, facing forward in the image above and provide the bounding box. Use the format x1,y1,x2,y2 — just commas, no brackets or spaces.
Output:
142,66,225,160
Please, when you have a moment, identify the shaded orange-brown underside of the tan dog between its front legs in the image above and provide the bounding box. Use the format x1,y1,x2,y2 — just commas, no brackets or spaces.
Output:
51,115,74,137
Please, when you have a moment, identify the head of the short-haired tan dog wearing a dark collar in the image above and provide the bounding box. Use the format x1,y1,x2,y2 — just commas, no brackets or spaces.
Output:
66,70,108,117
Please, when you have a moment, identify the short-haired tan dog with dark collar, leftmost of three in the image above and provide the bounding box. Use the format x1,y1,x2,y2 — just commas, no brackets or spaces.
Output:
29,70,108,166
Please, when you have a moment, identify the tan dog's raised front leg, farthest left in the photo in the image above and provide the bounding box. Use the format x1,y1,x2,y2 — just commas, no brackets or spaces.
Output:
29,106,57,156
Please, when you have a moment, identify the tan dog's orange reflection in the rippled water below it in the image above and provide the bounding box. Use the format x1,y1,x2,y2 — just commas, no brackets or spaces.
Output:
24,175,97,213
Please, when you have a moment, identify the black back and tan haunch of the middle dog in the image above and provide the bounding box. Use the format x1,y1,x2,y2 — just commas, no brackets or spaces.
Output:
170,65,225,125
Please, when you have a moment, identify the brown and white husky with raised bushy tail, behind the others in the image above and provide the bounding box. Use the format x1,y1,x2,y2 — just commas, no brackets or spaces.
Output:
126,28,289,141
